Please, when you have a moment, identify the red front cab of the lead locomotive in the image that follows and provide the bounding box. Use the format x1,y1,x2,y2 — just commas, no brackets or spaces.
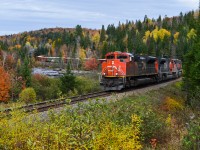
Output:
100,52,133,90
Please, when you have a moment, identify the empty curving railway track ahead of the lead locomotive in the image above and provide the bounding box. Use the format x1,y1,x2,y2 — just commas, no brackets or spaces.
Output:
3,92,111,113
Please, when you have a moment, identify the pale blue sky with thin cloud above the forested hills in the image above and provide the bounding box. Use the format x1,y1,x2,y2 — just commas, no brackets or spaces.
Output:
0,0,199,35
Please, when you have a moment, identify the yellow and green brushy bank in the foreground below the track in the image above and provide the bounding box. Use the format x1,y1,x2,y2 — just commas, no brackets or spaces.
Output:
0,82,199,150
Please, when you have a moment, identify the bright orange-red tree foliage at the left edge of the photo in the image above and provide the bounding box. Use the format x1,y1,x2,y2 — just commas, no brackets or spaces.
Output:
0,66,11,101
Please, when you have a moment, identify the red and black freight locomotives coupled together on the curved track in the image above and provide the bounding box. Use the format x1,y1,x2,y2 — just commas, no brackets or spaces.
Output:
100,51,182,91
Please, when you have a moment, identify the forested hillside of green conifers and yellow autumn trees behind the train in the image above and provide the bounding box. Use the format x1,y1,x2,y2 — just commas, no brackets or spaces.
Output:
0,11,198,65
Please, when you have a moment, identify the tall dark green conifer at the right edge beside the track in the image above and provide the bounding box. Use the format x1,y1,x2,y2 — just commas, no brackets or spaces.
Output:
183,14,200,107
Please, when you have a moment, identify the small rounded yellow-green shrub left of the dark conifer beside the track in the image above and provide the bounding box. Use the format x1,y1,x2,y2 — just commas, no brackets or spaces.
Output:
19,88,36,103
